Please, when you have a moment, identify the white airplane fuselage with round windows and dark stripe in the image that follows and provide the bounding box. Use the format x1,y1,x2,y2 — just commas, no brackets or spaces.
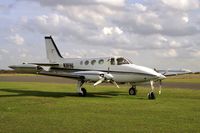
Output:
51,57,165,84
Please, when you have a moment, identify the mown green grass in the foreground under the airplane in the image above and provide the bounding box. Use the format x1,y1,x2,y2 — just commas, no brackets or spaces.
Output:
0,82,200,133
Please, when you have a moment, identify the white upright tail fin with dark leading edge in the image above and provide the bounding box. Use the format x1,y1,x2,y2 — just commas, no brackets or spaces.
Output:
45,36,63,63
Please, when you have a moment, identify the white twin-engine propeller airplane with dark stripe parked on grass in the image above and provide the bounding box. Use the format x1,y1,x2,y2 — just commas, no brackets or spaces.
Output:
9,36,166,99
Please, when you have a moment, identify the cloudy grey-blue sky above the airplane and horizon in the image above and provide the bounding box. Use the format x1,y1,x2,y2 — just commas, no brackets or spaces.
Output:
0,0,200,71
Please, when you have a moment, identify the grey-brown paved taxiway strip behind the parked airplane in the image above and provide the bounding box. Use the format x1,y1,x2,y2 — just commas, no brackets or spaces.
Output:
0,75,200,90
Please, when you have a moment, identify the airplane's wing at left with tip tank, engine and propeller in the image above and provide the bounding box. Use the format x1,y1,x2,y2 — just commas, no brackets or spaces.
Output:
9,63,119,88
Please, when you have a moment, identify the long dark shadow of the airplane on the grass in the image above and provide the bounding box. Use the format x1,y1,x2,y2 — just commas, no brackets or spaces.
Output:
0,88,130,98
